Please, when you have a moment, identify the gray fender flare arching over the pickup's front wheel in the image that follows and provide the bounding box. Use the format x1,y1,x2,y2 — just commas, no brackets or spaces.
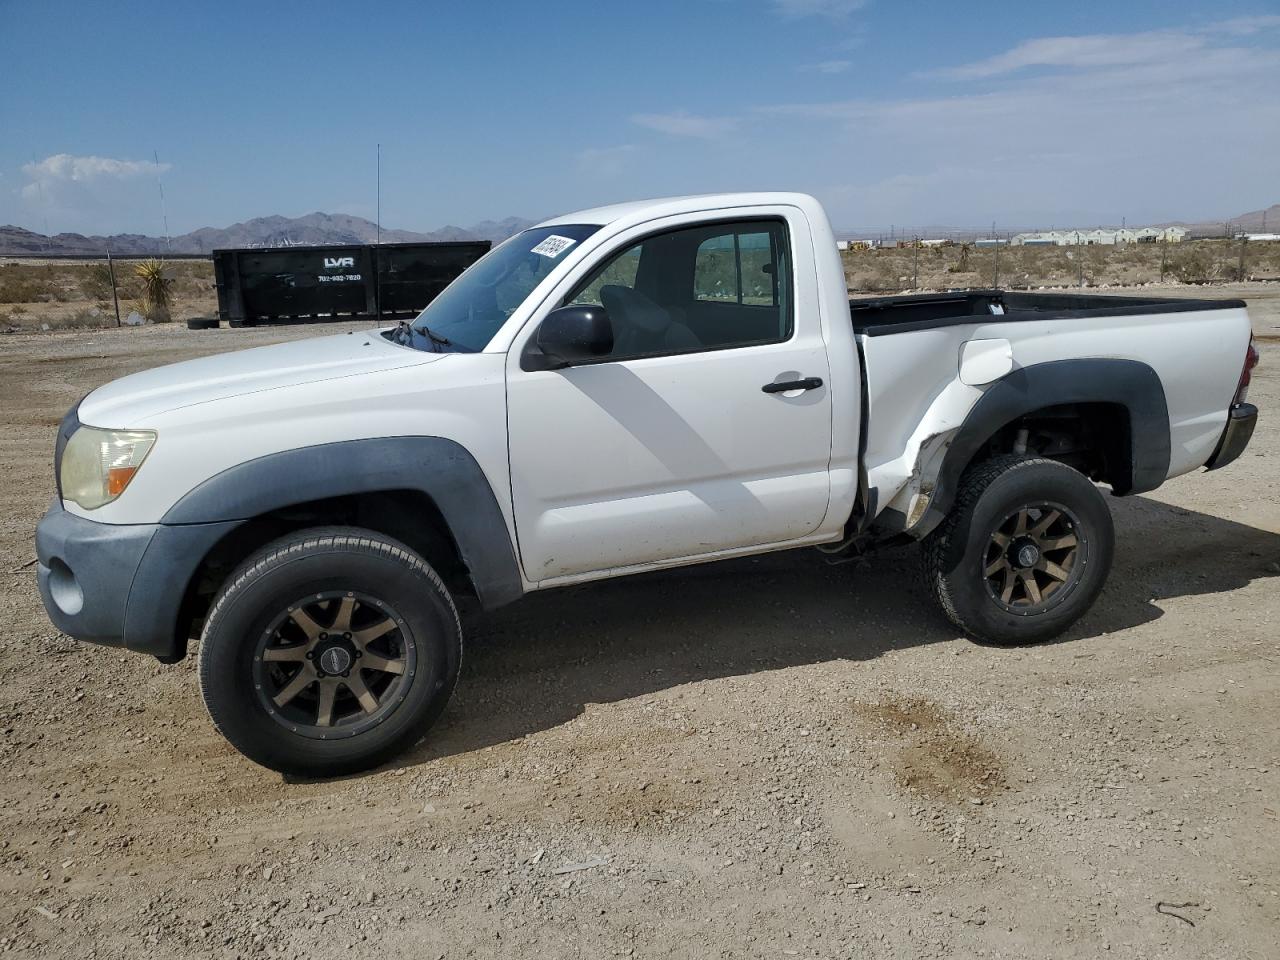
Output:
160,436,524,609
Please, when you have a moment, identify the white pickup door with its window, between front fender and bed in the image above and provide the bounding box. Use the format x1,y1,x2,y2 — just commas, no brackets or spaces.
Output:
507,209,831,582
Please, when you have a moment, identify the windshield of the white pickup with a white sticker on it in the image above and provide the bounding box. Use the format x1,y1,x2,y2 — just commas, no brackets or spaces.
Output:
397,224,600,353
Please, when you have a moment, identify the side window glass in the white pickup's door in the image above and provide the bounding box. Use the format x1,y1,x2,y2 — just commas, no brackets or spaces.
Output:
564,220,792,360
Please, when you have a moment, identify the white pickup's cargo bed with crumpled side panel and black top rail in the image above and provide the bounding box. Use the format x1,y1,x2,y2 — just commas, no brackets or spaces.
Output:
849,291,1249,537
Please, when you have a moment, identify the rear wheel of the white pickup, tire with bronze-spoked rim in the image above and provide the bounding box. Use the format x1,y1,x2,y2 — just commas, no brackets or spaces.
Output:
923,457,1115,644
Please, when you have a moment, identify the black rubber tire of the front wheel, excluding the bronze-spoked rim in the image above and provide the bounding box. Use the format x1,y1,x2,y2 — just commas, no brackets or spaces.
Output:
198,527,462,777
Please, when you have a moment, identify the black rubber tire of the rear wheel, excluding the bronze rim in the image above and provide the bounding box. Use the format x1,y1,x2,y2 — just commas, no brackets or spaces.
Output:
922,456,1115,645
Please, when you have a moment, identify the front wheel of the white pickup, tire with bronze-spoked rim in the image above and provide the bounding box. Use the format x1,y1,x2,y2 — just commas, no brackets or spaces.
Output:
200,527,462,777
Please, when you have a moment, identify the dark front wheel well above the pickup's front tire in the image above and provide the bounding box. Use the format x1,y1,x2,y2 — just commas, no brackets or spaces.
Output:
177,490,475,650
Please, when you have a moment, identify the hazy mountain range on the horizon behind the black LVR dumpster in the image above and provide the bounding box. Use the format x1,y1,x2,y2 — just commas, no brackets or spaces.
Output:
0,212,535,256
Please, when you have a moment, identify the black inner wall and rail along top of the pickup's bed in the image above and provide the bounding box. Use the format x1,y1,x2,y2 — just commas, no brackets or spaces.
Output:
849,289,1244,337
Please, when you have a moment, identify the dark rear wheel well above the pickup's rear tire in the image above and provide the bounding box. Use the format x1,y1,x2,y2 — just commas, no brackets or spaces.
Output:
966,403,1133,494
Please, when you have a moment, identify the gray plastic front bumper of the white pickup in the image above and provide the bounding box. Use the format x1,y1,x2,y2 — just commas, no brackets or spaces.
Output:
36,500,238,660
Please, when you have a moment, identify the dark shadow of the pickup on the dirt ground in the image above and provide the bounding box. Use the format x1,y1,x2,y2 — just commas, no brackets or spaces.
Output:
402,497,1280,765
